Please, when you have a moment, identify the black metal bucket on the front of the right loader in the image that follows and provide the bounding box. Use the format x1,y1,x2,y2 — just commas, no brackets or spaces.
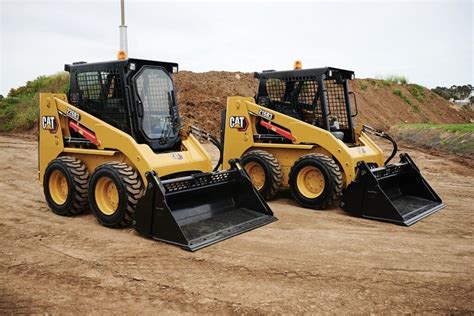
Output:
341,154,445,226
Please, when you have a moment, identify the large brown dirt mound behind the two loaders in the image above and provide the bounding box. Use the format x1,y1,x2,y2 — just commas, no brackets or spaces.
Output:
175,71,474,136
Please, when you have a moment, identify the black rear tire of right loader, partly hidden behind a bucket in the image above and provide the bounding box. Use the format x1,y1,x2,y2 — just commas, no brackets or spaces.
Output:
240,150,283,200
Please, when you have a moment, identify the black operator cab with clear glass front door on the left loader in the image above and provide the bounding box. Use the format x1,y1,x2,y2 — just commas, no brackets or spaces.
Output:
64,58,181,152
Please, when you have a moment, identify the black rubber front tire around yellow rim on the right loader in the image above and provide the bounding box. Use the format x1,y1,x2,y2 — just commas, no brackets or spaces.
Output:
289,154,342,209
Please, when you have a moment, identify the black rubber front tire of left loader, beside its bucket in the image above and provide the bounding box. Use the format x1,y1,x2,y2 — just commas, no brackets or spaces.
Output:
89,162,143,227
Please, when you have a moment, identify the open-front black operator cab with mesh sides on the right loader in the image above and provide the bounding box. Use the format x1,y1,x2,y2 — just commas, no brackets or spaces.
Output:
255,67,357,143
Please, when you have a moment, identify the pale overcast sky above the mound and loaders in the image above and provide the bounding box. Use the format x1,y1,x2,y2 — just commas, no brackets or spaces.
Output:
0,0,474,95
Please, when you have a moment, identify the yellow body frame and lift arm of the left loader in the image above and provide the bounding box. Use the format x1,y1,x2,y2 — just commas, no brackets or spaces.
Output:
38,93,212,186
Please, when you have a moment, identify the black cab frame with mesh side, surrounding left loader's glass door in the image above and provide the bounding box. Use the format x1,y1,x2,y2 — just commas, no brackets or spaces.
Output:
64,58,181,151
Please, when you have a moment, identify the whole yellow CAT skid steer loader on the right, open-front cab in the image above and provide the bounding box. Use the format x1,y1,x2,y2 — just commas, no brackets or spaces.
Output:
221,68,444,225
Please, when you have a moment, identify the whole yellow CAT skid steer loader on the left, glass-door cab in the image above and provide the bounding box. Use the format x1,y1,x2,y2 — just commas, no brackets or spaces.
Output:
39,59,276,250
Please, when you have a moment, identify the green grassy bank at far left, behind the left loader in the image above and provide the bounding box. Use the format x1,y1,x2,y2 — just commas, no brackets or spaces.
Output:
0,73,69,132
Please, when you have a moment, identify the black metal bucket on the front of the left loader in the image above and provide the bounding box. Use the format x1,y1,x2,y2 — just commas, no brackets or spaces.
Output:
135,161,276,251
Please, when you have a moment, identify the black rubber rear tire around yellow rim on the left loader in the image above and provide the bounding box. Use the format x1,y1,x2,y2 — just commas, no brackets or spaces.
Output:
43,156,89,216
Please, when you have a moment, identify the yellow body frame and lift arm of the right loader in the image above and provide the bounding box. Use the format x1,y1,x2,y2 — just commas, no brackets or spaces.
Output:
223,97,384,187
